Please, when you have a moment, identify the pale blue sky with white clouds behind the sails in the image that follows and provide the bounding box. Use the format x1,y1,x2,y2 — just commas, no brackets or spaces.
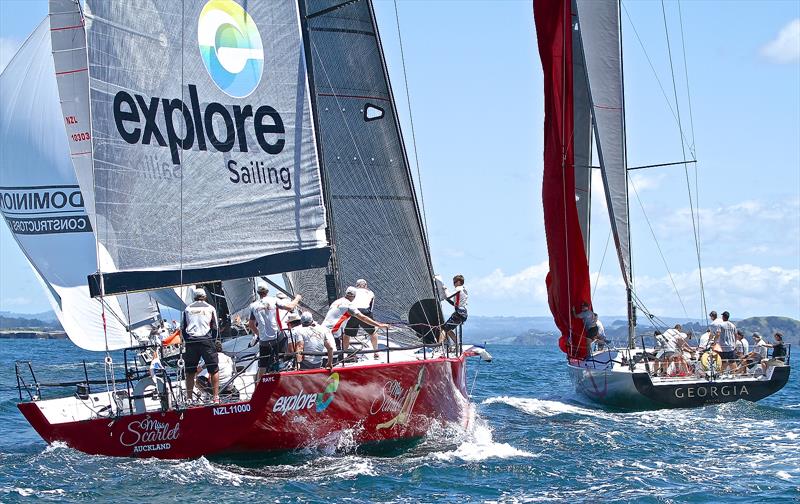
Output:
0,0,800,320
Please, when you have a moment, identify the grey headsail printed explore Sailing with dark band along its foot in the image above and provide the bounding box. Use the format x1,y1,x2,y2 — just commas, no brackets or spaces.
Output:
79,0,330,295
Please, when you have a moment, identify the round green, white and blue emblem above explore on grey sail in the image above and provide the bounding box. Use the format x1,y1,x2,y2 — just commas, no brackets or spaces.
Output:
197,0,264,98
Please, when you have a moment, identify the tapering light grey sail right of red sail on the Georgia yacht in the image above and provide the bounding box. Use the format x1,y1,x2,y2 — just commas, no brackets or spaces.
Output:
576,0,631,286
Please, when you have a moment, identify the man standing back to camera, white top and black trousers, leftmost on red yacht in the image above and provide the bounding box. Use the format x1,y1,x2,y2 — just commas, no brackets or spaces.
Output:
181,289,219,402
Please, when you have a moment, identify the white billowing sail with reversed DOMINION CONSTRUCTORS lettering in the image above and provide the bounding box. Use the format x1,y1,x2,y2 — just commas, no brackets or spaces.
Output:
0,18,151,350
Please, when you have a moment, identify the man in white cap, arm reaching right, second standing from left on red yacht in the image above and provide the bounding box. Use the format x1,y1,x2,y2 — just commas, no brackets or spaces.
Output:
247,284,303,383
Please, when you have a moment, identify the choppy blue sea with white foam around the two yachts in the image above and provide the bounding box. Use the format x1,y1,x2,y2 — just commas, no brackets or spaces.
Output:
0,340,800,503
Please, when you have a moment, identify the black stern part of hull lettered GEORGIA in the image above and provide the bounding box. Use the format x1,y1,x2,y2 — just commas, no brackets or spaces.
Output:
633,366,790,408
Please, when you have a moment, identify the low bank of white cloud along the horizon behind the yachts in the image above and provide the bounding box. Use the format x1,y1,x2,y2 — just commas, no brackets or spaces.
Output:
468,261,800,320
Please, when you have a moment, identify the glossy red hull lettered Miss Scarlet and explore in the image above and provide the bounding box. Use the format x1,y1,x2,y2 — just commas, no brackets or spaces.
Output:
19,357,468,458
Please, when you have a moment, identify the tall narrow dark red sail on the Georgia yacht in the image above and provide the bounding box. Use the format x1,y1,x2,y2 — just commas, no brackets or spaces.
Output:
533,0,591,359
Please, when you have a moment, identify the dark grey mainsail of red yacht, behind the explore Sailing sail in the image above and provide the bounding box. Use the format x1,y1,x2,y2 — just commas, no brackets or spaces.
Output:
291,0,440,336
